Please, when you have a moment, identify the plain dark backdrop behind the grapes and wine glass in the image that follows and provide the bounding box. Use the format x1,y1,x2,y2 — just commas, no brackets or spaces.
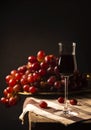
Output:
0,0,91,129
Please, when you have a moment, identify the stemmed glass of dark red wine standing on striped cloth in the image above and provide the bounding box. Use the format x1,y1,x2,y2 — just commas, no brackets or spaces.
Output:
58,43,77,116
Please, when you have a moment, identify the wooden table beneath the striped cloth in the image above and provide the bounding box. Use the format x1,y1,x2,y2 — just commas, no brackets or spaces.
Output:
21,92,91,130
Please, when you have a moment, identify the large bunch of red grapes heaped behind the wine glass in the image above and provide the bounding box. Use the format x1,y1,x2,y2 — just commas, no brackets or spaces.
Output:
0,50,87,106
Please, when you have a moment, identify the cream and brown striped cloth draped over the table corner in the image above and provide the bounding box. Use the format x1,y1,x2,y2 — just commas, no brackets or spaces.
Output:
19,97,91,125
